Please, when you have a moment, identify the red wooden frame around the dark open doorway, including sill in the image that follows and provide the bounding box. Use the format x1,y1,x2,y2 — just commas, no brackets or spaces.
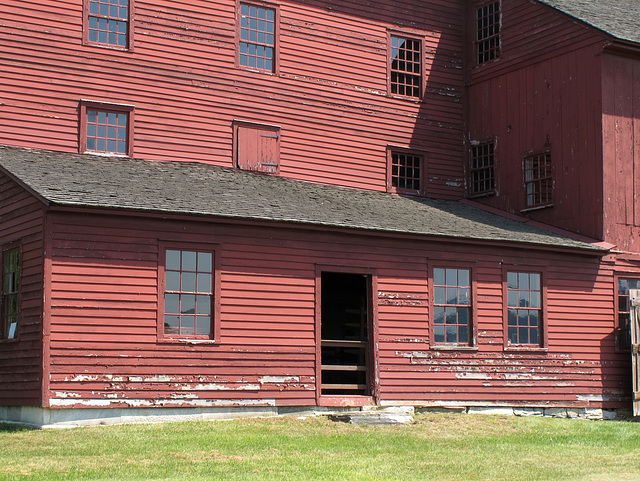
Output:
315,264,380,406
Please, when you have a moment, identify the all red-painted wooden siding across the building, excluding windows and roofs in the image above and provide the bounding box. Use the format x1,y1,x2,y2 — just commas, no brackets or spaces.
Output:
0,0,640,416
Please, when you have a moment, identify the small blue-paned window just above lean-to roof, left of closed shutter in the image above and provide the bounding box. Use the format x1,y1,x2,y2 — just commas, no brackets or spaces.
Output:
86,108,129,155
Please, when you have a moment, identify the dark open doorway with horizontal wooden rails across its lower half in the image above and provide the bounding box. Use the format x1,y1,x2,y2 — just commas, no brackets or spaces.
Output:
320,272,371,396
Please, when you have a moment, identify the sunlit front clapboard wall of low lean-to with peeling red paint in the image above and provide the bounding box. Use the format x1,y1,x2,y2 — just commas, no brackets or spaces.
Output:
47,214,630,408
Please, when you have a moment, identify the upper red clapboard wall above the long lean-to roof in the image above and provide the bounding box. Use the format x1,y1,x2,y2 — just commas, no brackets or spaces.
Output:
0,0,463,197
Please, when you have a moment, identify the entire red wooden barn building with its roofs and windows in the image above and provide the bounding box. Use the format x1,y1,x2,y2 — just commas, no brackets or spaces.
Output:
0,0,640,425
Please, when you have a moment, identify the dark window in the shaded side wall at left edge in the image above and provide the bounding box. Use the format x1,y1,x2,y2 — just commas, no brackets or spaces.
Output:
0,249,20,339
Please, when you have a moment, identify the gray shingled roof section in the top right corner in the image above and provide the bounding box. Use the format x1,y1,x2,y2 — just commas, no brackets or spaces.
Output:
538,0,640,43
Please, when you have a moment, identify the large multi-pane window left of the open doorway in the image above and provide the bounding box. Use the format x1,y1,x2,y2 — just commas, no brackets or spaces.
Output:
164,249,213,338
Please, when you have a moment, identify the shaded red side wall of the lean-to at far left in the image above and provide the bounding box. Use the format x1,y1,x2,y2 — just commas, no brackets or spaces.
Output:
0,175,44,406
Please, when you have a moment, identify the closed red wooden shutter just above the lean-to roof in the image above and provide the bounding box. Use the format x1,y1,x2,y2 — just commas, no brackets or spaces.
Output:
233,122,280,174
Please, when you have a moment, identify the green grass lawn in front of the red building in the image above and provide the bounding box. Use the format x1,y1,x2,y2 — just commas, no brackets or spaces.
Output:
0,414,640,481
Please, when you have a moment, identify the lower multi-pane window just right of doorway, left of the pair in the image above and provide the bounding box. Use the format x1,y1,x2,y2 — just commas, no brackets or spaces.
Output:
433,267,471,344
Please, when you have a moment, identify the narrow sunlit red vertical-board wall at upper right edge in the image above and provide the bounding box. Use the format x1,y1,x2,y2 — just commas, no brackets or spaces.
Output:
602,54,640,252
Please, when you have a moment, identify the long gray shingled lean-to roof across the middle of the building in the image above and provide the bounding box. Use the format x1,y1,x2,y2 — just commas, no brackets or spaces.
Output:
0,146,606,252
